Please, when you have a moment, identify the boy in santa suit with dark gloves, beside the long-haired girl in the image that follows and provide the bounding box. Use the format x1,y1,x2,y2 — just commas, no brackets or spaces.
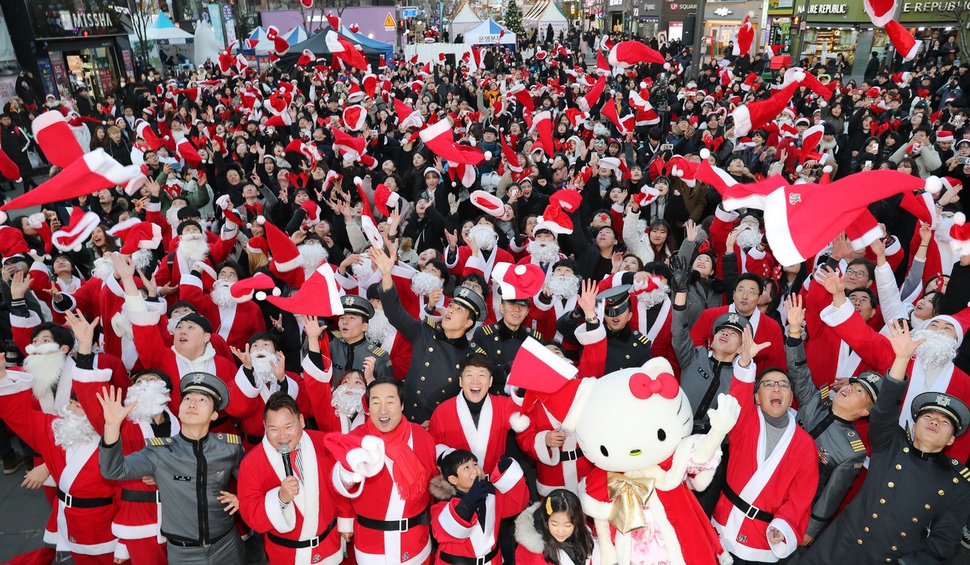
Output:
428,449,529,565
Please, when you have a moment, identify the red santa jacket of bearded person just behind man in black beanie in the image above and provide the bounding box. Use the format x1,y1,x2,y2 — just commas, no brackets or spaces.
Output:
179,273,266,351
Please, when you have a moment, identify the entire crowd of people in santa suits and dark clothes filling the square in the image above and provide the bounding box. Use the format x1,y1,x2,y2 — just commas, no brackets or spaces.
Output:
0,17,970,565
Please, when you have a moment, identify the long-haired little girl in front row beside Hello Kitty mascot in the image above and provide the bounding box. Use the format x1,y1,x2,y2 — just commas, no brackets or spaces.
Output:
515,488,600,565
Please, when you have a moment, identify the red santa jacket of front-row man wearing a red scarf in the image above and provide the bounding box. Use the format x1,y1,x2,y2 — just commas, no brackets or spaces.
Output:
333,420,438,565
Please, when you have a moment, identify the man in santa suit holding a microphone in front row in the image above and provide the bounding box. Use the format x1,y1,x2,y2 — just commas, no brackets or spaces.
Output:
238,392,343,565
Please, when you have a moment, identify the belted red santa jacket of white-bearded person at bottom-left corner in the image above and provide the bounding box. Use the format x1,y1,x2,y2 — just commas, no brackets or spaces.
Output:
0,371,118,555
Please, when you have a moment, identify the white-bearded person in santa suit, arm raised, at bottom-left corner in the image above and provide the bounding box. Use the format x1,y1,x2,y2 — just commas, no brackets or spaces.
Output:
0,366,118,565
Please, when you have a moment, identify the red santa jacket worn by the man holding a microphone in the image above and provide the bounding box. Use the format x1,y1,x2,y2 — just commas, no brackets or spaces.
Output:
237,430,346,565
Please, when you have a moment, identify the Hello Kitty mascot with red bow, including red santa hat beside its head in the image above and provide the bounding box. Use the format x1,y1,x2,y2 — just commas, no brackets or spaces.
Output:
508,338,741,565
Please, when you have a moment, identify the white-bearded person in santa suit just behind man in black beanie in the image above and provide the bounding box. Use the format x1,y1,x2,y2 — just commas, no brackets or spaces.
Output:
179,262,266,349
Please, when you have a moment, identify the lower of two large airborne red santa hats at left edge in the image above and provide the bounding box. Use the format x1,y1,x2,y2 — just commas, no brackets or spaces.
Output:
0,147,146,223
